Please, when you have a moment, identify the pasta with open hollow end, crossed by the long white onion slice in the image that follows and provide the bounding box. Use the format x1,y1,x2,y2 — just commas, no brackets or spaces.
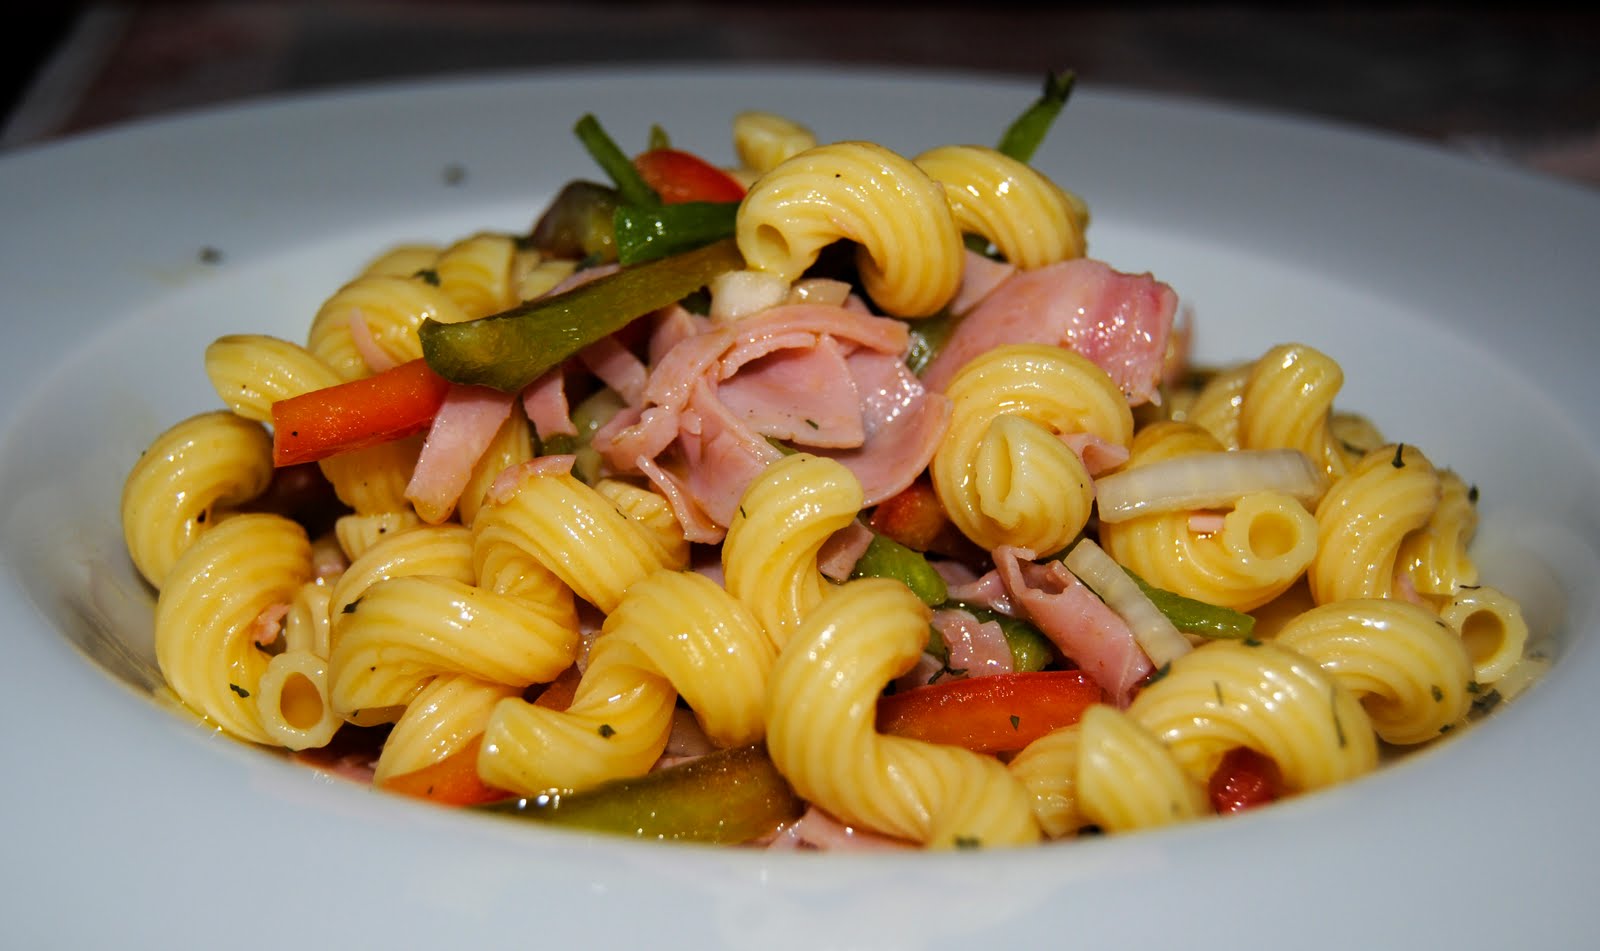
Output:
1099,423,1317,612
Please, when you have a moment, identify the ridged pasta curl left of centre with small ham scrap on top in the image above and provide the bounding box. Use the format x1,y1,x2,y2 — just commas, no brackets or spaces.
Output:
474,471,670,613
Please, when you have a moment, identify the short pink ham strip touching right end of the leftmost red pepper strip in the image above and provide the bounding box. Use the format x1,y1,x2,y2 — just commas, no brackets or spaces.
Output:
405,383,514,525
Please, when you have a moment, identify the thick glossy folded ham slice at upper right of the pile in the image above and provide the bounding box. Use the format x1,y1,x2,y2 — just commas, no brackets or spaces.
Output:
923,258,1178,405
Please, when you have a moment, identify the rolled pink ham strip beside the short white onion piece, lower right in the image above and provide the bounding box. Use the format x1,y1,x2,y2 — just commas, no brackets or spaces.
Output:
994,548,1150,706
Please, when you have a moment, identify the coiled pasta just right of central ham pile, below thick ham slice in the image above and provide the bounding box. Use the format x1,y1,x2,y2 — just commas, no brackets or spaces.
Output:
930,344,1133,552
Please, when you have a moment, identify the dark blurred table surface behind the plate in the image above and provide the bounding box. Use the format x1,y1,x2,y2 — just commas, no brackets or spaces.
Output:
0,0,1600,187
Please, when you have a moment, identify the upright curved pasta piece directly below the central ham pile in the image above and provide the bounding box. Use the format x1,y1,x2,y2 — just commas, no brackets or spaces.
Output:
722,453,862,648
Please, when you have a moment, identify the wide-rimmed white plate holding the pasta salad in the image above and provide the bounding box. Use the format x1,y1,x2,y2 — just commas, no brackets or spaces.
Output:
0,70,1600,951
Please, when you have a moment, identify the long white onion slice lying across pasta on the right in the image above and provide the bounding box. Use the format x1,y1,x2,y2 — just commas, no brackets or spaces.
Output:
1094,450,1328,522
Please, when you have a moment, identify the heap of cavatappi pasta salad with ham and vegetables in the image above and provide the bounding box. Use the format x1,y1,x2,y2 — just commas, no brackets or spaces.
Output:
122,86,1542,849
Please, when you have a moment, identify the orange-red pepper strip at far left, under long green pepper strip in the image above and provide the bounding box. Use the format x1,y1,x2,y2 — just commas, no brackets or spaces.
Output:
272,359,450,466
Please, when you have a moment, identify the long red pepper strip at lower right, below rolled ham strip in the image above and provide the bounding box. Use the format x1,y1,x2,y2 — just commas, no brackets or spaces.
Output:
878,671,1106,752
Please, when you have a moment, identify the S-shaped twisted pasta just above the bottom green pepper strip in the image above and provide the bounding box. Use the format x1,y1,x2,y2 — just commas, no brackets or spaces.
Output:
478,570,776,796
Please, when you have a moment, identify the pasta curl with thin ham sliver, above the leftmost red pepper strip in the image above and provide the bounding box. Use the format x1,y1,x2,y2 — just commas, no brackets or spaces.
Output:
307,275,467,379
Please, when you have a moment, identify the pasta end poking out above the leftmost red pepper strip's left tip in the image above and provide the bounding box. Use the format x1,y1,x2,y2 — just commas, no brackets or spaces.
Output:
205,333,339,423
